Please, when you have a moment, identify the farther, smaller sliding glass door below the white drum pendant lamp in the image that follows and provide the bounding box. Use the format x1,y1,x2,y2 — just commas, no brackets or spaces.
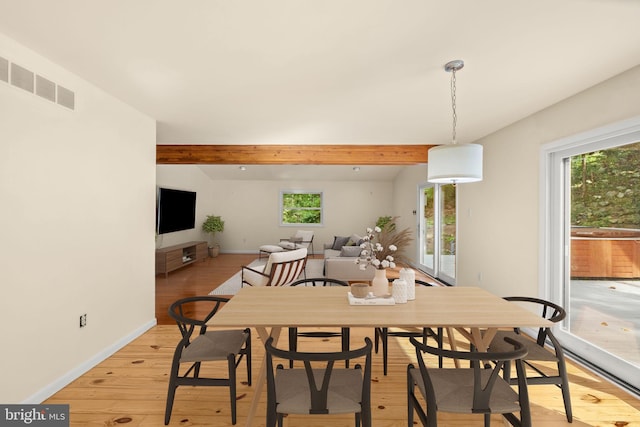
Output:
418,184,457,285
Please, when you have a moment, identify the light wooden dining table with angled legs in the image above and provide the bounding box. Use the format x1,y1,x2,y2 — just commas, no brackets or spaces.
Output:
208,286,551,426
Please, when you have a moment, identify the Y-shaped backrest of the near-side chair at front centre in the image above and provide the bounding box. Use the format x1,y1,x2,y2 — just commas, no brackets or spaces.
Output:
265,338,372,414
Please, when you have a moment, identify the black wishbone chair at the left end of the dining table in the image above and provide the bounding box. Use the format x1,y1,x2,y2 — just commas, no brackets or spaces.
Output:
164,295,251,425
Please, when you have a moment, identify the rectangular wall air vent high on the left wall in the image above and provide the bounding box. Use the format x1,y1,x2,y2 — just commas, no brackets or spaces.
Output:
0,56,76,110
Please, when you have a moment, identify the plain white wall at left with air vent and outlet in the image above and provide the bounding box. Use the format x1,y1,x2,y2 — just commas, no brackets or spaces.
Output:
0,34,155,403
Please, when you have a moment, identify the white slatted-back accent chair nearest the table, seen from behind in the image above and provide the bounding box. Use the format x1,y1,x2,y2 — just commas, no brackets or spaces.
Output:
242,248,307,286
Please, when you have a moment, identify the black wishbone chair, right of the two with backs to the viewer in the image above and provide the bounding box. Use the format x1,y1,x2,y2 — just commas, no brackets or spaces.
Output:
407,337,531,427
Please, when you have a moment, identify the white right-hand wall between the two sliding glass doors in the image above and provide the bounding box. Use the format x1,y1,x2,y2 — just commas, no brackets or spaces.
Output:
458,67,640,296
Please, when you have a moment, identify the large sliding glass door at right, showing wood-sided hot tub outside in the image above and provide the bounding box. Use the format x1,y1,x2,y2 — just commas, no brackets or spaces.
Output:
547,122,640,389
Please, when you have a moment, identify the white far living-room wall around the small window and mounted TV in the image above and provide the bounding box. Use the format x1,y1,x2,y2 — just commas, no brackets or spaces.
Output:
157,165,395,253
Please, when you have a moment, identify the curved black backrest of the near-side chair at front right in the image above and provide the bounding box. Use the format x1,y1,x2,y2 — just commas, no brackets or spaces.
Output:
410,337,529,413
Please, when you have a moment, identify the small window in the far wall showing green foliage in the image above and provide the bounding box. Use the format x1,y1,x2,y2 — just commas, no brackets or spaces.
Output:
280,191,322,225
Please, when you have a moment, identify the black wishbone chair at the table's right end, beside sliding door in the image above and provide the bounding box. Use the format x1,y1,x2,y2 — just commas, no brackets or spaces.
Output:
489,297,573,422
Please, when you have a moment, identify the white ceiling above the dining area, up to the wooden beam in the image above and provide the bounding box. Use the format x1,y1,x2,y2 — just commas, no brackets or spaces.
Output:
0,0,640,179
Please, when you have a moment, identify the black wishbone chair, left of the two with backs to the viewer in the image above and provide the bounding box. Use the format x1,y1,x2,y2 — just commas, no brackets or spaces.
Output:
265,338,372,427
